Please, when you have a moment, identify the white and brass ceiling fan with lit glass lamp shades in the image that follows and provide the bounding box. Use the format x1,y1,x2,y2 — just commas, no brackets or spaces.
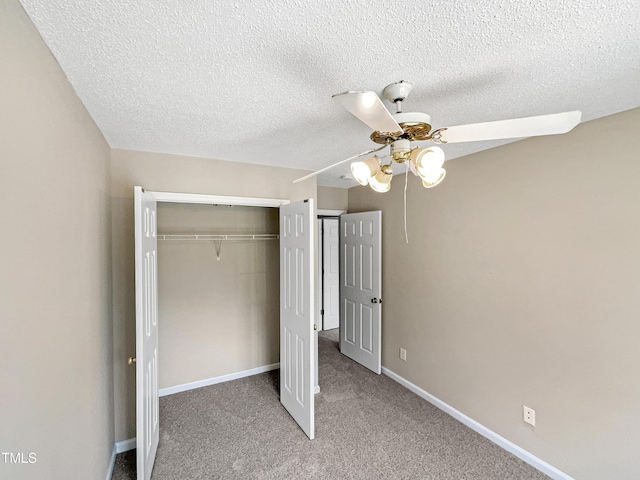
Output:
294,80,582,192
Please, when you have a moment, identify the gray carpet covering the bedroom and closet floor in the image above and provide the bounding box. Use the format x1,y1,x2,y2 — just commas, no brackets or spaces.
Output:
113,330,548,480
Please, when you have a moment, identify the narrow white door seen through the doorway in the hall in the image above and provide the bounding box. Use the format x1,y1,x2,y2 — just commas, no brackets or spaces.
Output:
322,218,340,330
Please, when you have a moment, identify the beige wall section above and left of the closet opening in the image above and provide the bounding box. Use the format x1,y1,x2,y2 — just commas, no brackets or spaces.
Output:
111,149,316,441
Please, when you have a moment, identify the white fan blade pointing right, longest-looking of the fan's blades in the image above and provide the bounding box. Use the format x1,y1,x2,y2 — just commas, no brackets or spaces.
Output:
436,110,582,143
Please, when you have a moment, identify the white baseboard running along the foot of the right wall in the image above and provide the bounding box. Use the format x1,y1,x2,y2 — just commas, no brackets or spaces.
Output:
382,367,574,480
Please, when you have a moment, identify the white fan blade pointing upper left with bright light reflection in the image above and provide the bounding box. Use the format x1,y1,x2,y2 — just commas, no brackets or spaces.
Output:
331,91,402,133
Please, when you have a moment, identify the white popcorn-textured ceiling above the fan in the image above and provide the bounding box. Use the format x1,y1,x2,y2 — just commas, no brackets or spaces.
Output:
21,0,640,187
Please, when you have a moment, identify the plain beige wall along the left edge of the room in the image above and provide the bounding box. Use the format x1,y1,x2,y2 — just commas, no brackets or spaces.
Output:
0,0,114,480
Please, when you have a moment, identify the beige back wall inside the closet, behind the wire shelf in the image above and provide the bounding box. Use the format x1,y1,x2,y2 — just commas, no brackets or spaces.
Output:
158,203,280,388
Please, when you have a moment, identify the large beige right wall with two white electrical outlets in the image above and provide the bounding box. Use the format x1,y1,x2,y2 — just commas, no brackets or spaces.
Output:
349,109,640,480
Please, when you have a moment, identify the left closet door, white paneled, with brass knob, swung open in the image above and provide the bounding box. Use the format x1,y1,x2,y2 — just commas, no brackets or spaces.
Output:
134,187,160,480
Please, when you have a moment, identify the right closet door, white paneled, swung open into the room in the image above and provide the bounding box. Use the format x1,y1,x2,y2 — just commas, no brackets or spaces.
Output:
280,199,315,440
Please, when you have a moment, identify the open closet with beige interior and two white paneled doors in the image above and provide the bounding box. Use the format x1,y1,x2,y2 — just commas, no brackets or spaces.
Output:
134,190,318,478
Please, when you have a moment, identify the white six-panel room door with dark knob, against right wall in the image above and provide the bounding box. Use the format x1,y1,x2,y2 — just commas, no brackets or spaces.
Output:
340,211,382,374
